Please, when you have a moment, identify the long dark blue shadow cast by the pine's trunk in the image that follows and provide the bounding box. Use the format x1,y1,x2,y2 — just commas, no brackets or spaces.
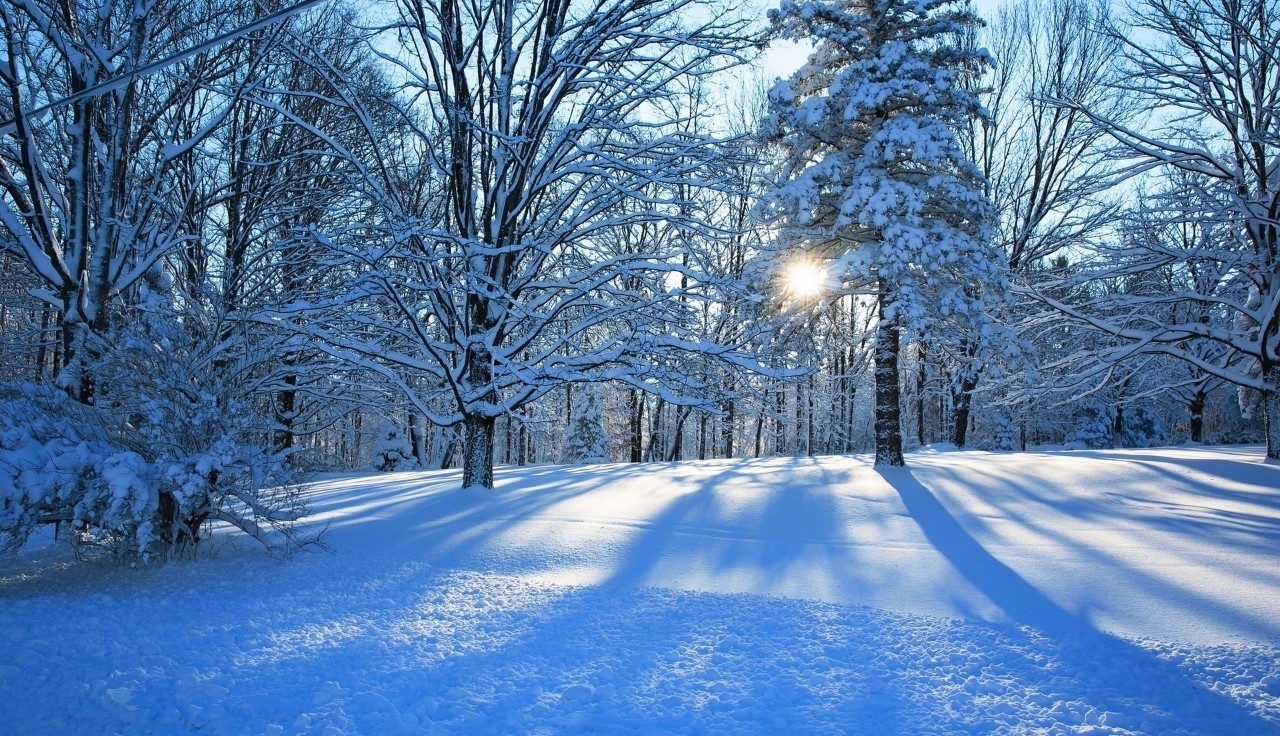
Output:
876,468,1280,733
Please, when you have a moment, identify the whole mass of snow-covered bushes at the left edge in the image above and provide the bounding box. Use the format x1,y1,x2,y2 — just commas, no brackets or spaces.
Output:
0,302,316,562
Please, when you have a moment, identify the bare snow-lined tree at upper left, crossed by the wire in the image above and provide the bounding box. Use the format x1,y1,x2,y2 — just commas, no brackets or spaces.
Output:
0,0,250,402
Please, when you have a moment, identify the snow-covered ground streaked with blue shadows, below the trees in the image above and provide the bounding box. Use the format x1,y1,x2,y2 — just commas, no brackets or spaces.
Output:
0,447,1280,735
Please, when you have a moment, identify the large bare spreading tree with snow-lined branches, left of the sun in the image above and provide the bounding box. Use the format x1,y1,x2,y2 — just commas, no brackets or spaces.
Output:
279,0,750,488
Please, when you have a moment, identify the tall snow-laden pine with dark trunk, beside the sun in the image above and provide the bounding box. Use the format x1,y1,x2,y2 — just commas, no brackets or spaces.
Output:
764,0,1005,465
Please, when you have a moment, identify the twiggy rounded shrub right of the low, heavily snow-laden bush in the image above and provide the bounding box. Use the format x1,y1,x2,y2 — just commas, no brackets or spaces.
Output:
95,312,307,556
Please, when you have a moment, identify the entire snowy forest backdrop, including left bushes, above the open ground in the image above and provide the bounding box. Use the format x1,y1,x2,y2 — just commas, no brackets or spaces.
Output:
0,0,1280,559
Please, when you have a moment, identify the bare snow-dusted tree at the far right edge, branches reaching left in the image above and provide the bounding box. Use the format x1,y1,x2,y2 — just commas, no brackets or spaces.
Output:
1044,0,1280,458
